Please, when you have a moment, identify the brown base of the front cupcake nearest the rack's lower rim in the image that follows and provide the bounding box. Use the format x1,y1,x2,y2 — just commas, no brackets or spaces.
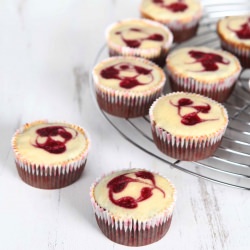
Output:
152,130,221,161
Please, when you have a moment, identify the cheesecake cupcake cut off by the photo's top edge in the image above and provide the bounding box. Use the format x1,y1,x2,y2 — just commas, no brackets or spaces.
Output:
140,0,202,43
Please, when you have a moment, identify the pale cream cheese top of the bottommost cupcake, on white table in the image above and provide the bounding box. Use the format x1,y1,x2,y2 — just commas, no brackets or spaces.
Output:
93,169,175,221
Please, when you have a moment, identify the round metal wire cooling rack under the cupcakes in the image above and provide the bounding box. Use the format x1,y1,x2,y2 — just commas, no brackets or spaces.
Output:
90,0,250,190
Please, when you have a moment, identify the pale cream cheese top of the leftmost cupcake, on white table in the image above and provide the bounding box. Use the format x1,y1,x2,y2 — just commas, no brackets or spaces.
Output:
13,122,89,166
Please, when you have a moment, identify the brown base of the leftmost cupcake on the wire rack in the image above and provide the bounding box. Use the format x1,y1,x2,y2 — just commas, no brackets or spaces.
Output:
96,92,160,119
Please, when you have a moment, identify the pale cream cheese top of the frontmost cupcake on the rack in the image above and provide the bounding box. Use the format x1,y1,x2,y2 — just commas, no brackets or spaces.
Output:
151,92,228,137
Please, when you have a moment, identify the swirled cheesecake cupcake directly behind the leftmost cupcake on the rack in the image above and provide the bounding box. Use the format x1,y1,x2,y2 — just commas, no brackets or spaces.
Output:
106,19,173,67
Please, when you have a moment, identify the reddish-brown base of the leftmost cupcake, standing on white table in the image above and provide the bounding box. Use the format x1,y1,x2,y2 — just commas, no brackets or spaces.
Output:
16,161,86,189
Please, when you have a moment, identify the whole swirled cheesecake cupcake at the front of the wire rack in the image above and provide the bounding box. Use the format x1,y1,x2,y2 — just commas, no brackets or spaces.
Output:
149,92,228,161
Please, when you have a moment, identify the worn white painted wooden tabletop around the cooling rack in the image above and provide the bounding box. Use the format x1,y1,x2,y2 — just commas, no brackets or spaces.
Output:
0,0,250,250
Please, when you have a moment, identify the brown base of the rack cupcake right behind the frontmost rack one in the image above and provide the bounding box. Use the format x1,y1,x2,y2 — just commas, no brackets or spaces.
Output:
169,76,236,103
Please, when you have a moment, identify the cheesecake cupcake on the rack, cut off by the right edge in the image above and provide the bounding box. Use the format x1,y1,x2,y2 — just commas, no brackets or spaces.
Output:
217,15,250,68
